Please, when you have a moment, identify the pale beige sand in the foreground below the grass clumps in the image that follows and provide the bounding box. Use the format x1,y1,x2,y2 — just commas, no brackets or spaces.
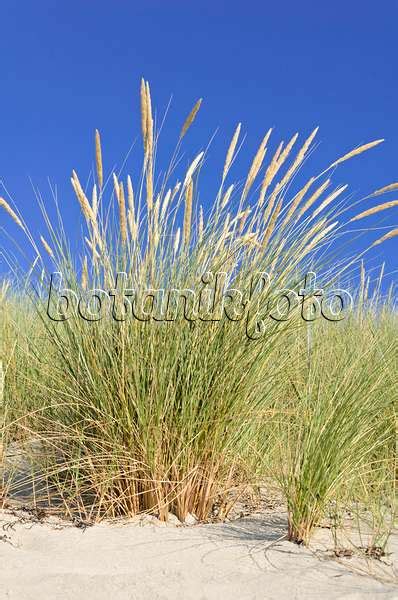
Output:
0,510,398,600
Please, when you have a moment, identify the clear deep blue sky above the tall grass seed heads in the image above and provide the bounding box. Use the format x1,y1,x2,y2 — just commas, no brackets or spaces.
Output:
0,0,398,290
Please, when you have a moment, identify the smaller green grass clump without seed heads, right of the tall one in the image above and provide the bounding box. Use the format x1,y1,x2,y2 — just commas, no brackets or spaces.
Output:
277,314,398,544
